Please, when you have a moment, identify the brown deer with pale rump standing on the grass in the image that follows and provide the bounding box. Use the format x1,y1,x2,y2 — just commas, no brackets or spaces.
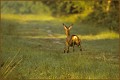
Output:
63,23,82,53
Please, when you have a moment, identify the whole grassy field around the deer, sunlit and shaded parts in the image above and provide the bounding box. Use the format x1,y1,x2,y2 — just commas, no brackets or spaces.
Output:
1,14,119,79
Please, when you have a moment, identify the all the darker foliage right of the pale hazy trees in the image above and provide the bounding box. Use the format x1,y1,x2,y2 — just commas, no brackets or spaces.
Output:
42,0,119,31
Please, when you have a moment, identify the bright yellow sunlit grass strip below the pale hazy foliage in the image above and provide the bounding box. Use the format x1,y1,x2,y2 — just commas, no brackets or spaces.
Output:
1,14,54,21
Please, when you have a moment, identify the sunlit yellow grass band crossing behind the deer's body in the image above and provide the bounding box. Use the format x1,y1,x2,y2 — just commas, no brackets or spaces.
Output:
22,31,119,40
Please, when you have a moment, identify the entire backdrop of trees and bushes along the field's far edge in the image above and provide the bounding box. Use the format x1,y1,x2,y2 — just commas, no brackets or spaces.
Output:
1,0,119,31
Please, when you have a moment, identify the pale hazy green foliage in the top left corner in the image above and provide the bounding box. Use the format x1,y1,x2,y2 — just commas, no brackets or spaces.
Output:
1,1,51,15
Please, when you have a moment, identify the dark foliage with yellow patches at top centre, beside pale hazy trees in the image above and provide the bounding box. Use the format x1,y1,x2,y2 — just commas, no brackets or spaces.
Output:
42,0,93,16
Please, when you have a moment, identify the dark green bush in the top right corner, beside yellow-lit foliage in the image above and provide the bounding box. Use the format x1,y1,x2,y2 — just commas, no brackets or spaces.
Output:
83,1,119,32
